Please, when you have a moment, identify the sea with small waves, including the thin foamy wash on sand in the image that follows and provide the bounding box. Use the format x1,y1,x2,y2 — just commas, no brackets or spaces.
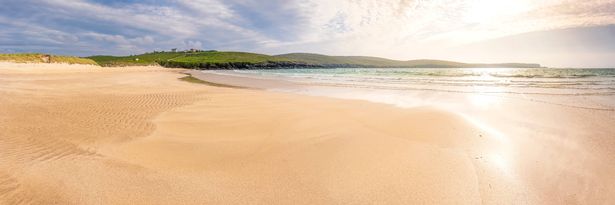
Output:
218,68,615,110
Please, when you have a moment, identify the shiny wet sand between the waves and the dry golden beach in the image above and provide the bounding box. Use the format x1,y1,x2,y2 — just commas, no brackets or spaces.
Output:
194,67,615,203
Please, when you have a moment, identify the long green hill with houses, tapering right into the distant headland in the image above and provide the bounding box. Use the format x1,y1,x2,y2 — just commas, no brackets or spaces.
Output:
88,51,540,69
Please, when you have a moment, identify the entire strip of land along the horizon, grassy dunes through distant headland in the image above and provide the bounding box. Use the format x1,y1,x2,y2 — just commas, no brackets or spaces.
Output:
0,49,541,70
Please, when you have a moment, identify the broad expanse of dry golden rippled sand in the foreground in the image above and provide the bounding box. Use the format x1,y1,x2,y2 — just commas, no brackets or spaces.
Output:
0,63,615,204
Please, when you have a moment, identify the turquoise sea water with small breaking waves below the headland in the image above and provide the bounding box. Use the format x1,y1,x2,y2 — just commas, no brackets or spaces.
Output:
235,68,615,96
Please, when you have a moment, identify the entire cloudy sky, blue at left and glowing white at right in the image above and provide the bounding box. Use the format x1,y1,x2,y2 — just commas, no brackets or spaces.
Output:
0,0,615,67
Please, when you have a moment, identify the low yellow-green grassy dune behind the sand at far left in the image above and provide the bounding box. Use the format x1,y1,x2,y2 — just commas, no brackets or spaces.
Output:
0,53,98,65
